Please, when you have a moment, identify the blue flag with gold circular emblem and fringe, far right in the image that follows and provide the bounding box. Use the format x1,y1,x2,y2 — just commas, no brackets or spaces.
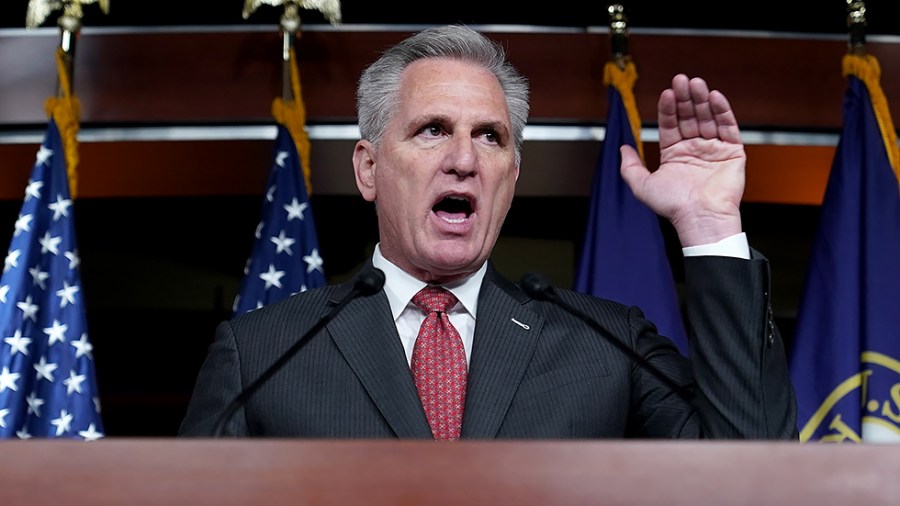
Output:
791,55,900,442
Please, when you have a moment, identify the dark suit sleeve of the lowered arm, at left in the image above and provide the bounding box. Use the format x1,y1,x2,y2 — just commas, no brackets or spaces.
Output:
178,322,248,437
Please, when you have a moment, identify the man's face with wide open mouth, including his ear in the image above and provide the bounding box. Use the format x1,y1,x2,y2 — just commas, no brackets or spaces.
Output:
353,58,519,282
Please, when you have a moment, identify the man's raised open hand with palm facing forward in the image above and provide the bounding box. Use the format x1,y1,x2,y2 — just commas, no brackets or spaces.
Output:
620,74,747,246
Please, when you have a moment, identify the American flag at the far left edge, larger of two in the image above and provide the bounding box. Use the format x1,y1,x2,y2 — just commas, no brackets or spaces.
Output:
0,120,104,440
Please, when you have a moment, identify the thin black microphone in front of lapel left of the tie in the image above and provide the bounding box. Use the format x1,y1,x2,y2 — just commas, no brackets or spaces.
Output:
213,267,384,438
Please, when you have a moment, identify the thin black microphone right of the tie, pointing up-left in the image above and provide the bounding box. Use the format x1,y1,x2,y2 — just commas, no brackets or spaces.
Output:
520,272,706,428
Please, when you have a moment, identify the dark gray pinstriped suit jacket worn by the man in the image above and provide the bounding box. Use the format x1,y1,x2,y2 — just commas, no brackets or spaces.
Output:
179,252,797,439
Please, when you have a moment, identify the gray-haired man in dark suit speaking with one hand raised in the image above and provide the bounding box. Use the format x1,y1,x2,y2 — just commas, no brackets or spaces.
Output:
180,26,797,440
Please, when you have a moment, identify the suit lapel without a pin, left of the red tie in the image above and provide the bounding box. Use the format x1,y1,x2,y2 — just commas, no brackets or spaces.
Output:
327,292,432,438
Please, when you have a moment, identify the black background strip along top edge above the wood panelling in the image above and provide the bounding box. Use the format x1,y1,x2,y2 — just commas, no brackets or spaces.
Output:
0,0,900,35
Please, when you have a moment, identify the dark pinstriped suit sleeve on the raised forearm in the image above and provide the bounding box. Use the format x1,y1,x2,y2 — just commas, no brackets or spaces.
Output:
685,247,798,439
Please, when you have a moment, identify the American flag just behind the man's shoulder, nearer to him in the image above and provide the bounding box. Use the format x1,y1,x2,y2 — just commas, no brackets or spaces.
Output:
233,124,325,315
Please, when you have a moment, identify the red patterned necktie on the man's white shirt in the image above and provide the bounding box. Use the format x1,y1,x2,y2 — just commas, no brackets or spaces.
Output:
412,286,466,441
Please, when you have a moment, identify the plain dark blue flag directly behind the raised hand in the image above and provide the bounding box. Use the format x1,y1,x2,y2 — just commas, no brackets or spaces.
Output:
575,63,688,355
